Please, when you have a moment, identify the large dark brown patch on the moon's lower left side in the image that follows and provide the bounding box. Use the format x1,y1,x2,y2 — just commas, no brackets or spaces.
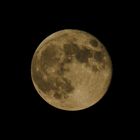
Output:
33,64,74,99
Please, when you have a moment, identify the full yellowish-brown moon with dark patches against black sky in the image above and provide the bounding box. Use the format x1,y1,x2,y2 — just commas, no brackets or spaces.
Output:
31,29,112,111
